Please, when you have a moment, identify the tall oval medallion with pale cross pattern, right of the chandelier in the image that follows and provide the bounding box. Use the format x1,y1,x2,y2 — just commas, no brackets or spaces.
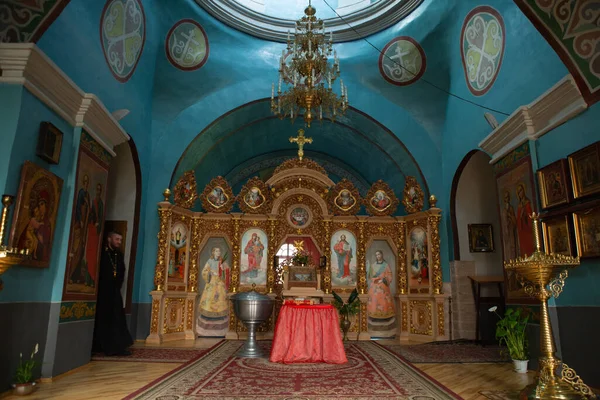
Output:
460,6,505,96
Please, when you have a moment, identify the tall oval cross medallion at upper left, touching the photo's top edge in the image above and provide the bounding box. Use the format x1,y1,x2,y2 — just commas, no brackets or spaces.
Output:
100,0,146,82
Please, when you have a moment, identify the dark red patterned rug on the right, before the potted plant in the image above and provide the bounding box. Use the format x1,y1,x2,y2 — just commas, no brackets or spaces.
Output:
385,341,510,364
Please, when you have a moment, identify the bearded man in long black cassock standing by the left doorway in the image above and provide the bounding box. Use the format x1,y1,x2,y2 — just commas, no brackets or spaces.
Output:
93,232,133,356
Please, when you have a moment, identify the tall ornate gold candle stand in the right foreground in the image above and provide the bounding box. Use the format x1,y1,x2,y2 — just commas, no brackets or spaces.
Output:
504,213,595,399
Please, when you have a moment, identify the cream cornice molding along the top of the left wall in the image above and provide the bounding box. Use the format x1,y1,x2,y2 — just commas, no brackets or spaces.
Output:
0,43,129,157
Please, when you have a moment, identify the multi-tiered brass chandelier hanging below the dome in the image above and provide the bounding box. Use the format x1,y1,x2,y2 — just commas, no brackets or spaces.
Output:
271,0,348,127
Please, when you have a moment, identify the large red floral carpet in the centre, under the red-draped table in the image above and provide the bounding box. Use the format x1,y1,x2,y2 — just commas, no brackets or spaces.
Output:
125,341,460,400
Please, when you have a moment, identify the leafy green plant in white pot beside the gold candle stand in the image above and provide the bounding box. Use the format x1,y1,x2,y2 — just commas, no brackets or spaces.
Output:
488,306,529,374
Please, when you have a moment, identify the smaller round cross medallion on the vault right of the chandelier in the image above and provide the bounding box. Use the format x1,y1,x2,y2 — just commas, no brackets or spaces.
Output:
379,36,427,86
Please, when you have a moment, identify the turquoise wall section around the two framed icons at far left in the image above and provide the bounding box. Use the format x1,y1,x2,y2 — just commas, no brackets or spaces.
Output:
0,90,81,302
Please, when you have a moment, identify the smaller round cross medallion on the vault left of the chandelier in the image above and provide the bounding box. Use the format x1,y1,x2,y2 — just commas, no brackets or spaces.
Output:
165,19,209,71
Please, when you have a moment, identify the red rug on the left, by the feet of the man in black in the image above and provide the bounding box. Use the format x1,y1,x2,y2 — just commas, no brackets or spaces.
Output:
92,347,207,363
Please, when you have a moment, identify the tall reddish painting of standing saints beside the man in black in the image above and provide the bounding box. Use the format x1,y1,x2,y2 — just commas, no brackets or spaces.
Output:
65,144,108,296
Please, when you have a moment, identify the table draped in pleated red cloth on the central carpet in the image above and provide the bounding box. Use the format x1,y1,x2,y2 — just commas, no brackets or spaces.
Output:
269,304,348,364
